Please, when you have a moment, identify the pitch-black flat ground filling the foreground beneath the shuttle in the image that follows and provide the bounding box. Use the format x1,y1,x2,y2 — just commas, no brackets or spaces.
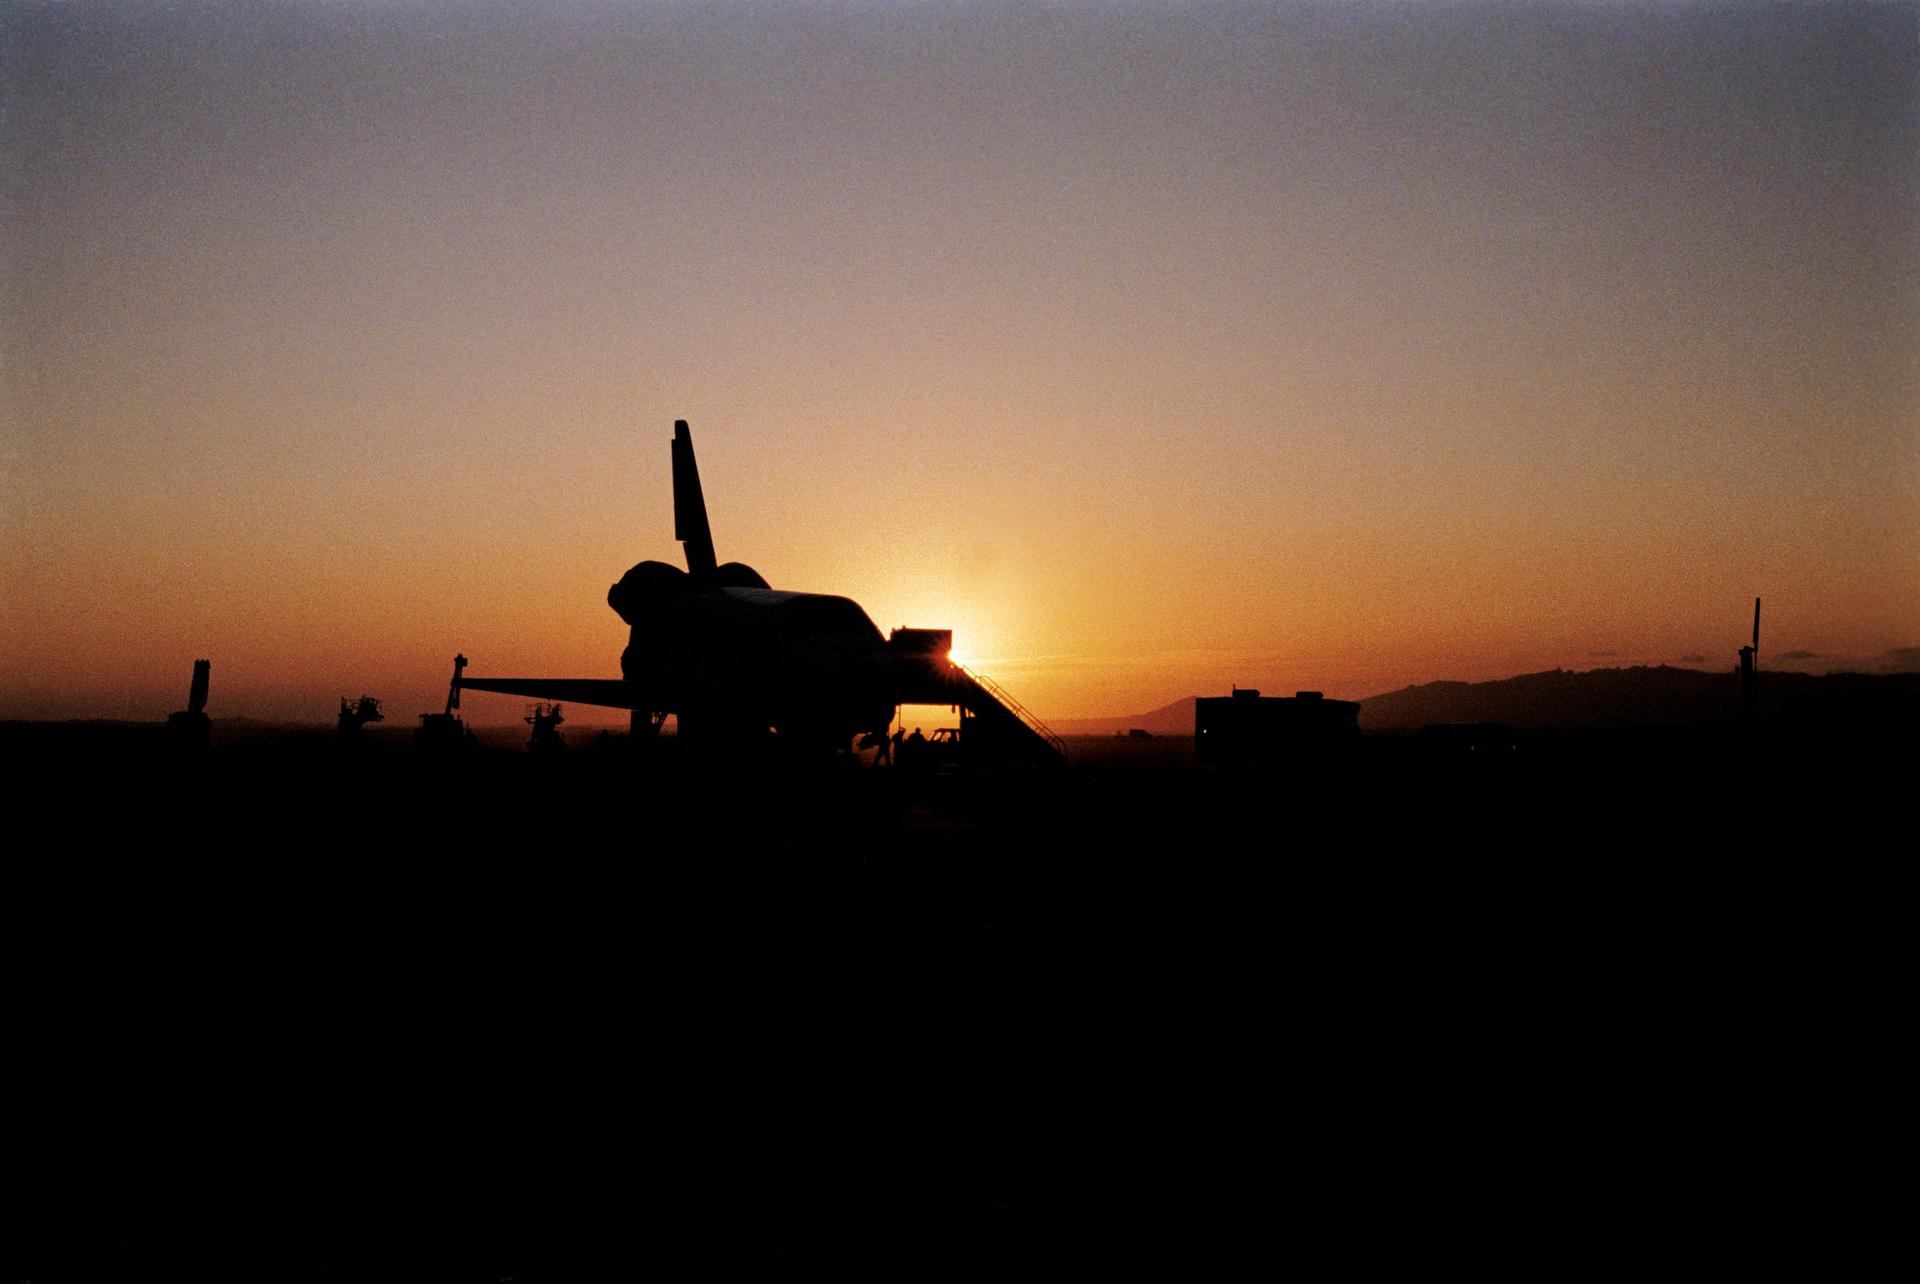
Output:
11,724,1914,1284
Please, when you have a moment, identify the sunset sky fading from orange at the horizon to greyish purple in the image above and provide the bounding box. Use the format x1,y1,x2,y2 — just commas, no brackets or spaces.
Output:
0,0,1920,720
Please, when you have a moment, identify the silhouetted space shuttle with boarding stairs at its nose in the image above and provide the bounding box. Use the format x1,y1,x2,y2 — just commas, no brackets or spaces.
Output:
455,420,1064,762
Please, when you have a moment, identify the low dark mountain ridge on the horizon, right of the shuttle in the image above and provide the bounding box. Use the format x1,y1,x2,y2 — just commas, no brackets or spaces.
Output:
1054,664,1920,735
